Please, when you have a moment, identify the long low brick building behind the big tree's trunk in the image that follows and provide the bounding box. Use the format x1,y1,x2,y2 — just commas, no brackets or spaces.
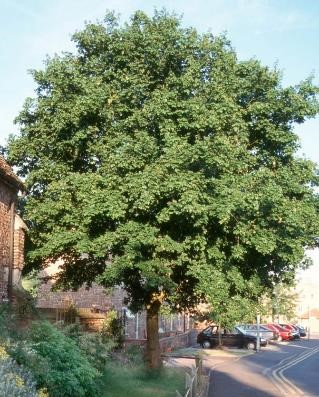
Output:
36,260,193,340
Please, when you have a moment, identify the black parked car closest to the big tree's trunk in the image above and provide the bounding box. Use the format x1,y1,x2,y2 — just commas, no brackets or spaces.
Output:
197,325,267,350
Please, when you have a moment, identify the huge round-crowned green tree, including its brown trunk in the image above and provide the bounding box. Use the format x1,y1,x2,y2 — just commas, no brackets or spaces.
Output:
8,11,318,367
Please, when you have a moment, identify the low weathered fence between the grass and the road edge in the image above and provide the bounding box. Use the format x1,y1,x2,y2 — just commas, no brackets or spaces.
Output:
176,358,208,397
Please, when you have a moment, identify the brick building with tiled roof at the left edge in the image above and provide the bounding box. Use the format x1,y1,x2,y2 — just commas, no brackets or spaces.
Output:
0,156,27,302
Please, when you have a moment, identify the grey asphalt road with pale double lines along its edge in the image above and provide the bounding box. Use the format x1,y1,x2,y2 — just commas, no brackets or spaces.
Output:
206,335,319,397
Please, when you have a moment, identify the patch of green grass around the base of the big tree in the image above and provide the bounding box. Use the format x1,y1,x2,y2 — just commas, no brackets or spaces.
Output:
102,364,185,397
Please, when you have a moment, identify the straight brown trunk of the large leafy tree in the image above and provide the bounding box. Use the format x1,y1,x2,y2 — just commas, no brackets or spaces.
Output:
146,301,162,369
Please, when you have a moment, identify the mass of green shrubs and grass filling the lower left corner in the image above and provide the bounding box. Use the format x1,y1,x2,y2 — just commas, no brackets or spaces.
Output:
0,305,184,397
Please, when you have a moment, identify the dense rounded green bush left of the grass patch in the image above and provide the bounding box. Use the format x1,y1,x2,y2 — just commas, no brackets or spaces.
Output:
11,322,100,397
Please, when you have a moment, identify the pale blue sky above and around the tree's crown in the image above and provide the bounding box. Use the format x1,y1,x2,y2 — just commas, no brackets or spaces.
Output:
0,0,319,163
